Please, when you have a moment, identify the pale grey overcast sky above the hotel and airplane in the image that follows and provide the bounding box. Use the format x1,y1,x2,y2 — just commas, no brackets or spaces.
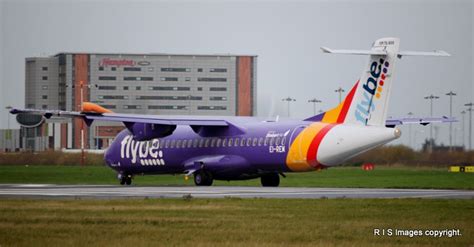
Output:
0,0,474,150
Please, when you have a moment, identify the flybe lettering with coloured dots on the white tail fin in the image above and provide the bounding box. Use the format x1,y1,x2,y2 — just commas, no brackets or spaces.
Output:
355,58,390,124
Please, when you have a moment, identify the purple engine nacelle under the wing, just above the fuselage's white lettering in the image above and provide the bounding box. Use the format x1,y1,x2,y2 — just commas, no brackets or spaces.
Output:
125,123,176,141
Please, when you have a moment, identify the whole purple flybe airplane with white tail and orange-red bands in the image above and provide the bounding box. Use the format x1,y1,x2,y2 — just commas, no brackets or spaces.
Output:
10,38,455,187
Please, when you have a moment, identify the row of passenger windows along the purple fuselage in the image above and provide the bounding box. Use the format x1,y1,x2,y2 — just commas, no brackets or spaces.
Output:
160,137,286,148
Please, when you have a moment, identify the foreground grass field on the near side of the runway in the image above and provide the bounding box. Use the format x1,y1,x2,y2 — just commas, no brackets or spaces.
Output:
0,199,474,246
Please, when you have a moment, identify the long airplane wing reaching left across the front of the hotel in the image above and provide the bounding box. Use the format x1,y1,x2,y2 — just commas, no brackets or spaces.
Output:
10,109,229,126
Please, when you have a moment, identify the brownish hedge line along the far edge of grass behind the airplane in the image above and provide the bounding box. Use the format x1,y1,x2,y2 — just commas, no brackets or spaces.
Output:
0,145,474,167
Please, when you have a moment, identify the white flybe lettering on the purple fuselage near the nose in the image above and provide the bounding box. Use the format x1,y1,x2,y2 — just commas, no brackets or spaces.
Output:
120,135,165,166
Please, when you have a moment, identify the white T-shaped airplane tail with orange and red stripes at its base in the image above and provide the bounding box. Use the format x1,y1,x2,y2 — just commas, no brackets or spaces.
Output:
306,38,449,126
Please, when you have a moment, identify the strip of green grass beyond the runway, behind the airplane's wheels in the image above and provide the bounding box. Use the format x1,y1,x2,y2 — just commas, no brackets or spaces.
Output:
0,166,474,189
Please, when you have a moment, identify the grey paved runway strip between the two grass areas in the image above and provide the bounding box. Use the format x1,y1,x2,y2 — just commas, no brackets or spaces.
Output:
0,184,474,199
